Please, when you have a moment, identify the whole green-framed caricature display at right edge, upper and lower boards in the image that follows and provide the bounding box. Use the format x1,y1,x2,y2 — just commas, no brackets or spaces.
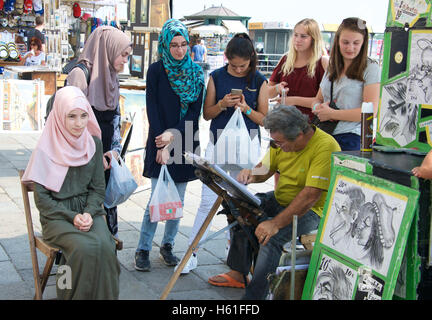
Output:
302,0,432,300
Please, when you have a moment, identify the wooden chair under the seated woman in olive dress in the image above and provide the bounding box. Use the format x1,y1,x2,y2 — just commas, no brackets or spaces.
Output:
19,170,123,300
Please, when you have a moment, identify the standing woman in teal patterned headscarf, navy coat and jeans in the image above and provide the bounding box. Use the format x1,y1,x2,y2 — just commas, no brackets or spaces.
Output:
135,19,204,271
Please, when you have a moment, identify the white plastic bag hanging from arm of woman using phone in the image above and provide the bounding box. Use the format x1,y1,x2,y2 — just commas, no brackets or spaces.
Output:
209,108,261,170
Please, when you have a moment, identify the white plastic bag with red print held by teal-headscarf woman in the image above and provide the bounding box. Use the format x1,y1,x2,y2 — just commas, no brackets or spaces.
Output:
149,165,183,222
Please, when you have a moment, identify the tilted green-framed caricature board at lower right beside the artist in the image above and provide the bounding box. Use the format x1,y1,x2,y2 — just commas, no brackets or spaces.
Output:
302,166,419,300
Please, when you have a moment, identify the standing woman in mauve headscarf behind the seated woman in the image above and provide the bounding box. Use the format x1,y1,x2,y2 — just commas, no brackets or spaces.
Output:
67,26,132,236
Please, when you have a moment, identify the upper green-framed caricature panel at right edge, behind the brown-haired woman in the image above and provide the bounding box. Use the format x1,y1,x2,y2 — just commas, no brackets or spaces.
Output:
376,29,432,153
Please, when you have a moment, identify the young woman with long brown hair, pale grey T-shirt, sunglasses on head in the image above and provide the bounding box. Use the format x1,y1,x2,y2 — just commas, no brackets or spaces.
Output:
311,18,381,151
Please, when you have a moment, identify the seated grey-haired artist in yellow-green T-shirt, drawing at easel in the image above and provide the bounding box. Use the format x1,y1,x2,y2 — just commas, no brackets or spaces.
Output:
208,106,340,300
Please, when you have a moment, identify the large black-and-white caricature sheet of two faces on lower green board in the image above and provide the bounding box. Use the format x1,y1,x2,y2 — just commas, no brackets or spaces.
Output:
322,178,407,274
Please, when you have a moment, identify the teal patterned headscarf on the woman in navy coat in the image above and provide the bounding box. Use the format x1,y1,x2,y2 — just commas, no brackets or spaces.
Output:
158,19,204,119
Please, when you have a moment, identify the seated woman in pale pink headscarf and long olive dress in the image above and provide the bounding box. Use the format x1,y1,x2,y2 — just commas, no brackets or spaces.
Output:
22,86,120,300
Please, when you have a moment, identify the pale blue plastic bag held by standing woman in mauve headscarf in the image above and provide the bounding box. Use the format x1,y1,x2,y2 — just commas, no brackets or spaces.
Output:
104,153,138,208
